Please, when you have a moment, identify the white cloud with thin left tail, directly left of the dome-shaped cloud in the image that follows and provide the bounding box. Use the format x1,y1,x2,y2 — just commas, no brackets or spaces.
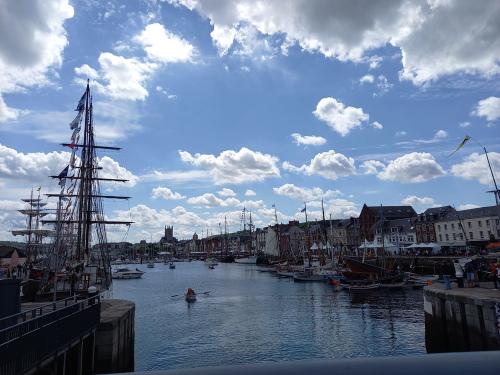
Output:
283,150,356,180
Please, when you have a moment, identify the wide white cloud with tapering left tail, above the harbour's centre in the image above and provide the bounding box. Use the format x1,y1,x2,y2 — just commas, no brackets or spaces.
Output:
179,147,280,185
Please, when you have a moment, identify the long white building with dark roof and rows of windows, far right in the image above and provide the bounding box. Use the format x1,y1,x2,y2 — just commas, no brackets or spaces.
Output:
434,206,500,251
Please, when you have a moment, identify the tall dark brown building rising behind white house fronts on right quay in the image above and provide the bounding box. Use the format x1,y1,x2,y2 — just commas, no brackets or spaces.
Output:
359,204,417,241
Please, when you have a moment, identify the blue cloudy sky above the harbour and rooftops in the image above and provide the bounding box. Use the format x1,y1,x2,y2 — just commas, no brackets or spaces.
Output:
0,0,500,242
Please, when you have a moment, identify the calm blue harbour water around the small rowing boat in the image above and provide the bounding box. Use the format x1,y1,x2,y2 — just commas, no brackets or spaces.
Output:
113,262,425,370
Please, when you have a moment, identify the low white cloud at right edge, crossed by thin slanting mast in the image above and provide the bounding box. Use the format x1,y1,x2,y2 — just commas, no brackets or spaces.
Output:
451,152,500,185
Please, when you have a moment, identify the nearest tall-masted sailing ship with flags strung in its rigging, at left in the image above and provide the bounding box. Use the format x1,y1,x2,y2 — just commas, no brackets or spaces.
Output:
23,81,132,299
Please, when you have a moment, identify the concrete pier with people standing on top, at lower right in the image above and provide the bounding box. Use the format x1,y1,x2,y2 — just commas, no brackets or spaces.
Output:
424,284,500,353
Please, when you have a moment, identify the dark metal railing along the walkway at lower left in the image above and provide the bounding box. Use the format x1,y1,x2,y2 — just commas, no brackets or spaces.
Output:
0,295,101,375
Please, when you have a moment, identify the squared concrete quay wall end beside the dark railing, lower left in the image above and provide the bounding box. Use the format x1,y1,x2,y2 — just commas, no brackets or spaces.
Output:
95,299,135,374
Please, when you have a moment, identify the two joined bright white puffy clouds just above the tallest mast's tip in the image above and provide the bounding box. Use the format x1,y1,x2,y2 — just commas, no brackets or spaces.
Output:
75,23,196,100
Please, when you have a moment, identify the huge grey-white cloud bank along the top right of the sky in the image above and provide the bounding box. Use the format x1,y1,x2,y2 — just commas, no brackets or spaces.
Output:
169,0,500,85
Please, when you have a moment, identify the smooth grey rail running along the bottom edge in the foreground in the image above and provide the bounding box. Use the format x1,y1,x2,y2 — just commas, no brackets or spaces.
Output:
110,352,500,375
